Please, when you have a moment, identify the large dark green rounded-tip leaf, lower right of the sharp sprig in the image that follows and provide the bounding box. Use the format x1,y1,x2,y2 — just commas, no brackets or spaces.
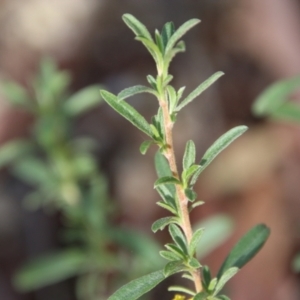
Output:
217,224,270,278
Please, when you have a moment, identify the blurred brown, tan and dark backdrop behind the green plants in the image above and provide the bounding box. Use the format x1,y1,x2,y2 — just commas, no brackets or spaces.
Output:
0,0,300,300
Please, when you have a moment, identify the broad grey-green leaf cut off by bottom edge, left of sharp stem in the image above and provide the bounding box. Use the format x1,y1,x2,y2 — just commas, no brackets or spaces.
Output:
107,270,165,300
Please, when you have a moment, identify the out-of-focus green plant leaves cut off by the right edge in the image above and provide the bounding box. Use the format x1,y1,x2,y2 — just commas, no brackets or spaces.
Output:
252,76,300,272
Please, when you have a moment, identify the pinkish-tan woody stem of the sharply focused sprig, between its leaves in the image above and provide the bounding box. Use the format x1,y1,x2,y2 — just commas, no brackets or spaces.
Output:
159,98,202,293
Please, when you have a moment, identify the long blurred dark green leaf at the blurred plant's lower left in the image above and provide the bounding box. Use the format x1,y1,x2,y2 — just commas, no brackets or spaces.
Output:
13,249,87,292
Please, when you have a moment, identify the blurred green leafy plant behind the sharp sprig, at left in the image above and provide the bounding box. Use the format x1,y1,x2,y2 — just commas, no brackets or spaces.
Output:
0,59,160,300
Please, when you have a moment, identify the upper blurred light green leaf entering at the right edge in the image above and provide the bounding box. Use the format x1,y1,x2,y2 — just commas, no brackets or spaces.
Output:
252,76,300,116
